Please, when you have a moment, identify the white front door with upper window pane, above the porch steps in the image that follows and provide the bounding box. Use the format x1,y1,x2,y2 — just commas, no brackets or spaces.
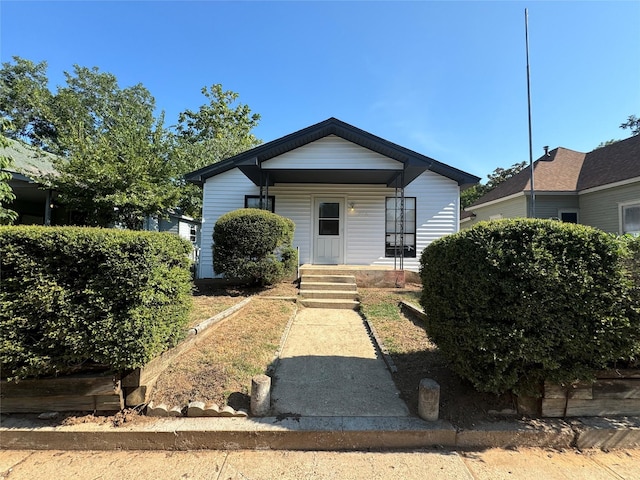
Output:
313,198,344,265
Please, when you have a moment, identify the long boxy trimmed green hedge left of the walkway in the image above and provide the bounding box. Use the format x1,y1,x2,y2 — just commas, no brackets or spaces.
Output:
0,227,191,378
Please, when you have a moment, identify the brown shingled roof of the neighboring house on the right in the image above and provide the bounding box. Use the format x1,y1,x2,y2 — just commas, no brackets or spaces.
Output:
467,135,640,210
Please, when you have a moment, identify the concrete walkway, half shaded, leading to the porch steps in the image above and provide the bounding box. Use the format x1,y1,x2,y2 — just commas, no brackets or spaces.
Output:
271,308,409,417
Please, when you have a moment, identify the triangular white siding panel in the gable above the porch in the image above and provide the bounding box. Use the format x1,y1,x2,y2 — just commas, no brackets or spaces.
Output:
262,135,402,170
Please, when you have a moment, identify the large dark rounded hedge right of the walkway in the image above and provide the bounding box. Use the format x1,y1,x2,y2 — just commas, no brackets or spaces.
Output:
421,219,640,394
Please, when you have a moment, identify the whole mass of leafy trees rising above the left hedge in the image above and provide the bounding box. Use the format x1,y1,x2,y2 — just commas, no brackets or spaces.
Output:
0,57,260,228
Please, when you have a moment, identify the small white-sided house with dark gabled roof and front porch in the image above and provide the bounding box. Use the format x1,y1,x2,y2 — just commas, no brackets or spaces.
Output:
186,118,479,278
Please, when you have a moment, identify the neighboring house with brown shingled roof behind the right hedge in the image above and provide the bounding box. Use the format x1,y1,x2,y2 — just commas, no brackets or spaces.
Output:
461,135,640,235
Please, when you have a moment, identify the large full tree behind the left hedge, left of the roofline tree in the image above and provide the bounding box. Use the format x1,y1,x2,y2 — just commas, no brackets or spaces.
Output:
50,66,179,229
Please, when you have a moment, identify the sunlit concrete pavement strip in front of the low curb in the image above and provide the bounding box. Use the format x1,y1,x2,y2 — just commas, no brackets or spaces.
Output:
0,449,640,480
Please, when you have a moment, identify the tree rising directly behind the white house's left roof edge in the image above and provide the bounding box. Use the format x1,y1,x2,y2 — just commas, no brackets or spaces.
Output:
173,84,261,218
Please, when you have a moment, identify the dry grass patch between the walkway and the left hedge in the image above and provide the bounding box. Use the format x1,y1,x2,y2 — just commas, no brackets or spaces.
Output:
151,296,295,409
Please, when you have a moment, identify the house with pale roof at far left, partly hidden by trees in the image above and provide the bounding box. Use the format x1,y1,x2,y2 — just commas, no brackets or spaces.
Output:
0,138,61,225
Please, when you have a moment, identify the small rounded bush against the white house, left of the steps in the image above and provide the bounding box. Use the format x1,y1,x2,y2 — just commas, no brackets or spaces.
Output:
213,208,298,285
